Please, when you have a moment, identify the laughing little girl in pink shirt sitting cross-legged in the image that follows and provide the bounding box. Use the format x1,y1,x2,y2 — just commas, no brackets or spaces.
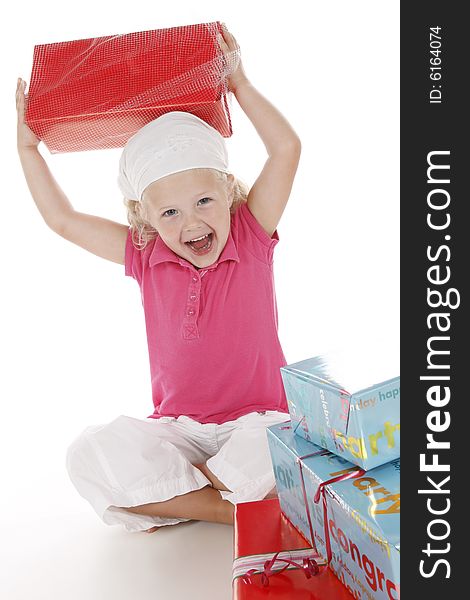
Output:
16,27,300,532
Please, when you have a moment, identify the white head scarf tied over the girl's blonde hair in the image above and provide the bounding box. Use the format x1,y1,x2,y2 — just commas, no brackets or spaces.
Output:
118,111,228,201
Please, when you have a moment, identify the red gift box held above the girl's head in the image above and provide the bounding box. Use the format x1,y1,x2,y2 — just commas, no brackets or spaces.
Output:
25,22,232,153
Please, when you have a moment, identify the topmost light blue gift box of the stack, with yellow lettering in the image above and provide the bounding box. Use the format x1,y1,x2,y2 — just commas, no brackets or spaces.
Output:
281,352,400,470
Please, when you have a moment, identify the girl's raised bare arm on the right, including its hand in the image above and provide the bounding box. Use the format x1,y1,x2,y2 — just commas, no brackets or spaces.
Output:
219,26,301,236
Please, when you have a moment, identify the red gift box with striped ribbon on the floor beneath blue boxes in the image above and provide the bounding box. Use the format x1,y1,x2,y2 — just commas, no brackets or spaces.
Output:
233,498,353,600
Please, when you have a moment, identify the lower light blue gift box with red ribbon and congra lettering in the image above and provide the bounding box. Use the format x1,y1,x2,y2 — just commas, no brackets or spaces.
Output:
267,422,400,600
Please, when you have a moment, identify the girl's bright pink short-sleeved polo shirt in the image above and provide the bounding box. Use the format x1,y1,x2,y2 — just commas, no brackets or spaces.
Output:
125,204,287,423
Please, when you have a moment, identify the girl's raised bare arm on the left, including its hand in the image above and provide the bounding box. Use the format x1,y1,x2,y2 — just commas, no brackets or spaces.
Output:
16,79,129,264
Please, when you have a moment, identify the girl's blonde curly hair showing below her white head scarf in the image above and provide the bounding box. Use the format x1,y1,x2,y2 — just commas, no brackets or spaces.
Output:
124,169,249,250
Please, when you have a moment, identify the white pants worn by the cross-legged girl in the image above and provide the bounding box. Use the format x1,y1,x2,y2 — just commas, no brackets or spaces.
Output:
67,411,289,531
